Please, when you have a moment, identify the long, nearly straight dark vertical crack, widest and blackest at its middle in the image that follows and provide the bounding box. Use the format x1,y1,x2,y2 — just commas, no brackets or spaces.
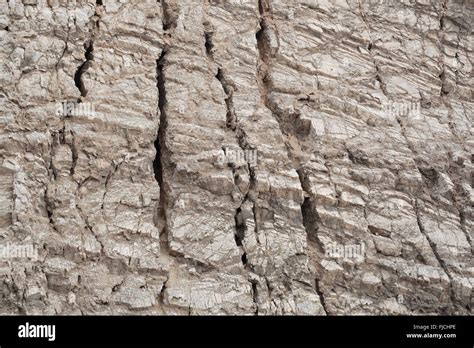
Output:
153,49,169,253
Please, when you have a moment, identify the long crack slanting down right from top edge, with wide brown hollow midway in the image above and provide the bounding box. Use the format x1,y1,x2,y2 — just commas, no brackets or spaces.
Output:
256,0,329,314
